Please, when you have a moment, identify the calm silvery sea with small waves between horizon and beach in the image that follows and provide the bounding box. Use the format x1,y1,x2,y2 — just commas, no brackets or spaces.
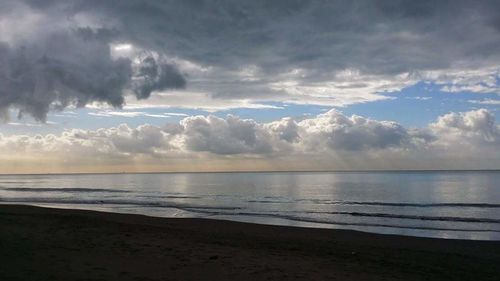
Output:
0,171,500,240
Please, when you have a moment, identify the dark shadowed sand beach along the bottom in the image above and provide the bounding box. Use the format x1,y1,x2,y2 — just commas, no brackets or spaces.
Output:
0,205,500,281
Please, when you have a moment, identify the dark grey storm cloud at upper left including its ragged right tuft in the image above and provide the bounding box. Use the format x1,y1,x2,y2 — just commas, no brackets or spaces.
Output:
0,0,186,121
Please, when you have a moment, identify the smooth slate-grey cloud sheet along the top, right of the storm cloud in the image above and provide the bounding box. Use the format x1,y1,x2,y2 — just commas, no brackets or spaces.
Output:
47,0,500,74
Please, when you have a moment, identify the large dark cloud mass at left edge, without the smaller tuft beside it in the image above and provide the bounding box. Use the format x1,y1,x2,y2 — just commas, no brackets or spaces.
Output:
0,29,132,120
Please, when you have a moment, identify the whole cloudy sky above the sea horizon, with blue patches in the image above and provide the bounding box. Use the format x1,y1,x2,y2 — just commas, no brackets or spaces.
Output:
0,0,500,173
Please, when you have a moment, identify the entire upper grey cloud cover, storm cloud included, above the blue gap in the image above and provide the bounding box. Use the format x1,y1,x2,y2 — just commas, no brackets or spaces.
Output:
0,0,500,120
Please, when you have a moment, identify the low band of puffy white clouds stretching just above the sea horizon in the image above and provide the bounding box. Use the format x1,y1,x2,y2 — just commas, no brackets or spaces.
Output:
0,109,500,171
